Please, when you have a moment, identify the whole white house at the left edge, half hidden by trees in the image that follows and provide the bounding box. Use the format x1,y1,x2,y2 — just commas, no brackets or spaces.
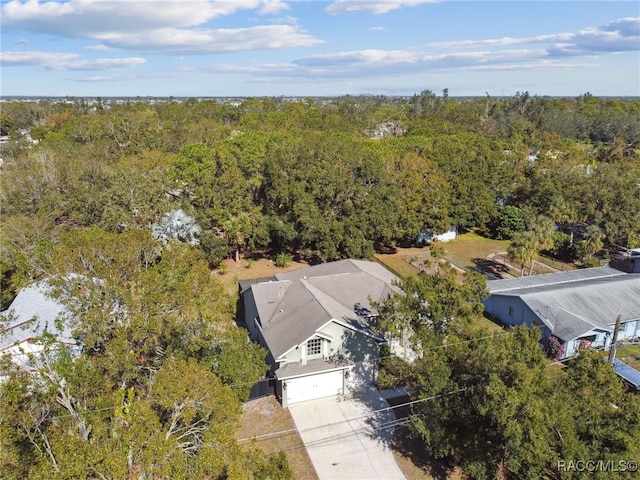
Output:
0,281,82,371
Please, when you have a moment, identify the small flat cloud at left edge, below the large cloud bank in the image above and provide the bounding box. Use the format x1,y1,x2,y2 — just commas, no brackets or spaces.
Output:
0,51,146,71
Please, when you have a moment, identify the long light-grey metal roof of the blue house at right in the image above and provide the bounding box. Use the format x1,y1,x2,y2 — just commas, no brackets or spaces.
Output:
488,267,640,341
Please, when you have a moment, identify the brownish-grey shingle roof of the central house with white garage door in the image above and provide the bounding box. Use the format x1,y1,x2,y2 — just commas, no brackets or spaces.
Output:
249,260,400,359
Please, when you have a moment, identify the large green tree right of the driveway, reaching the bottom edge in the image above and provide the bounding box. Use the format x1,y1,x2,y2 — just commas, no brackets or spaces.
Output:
411,328,555,479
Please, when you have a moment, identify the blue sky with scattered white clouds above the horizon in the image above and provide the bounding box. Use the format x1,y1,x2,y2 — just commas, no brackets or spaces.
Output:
0,0,640,96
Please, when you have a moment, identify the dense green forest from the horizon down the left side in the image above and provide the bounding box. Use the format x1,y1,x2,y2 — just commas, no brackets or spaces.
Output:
0,90,640,478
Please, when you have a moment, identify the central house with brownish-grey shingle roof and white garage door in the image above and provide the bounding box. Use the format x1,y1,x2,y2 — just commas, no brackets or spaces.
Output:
240,260,400,407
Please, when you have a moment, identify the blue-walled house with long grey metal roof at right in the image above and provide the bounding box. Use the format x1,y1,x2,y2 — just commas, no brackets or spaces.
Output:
484,267,640,359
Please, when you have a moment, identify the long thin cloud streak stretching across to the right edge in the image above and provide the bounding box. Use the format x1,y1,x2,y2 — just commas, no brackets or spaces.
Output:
139,19,639,85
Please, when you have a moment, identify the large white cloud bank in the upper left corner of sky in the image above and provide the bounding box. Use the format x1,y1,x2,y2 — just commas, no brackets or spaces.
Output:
1,0,310,53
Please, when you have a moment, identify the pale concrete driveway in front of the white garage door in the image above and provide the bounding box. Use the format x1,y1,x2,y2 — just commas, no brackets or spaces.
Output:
289,388,405,480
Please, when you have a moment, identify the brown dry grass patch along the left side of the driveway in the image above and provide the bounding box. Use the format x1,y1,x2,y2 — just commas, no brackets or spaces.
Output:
237,396,318,479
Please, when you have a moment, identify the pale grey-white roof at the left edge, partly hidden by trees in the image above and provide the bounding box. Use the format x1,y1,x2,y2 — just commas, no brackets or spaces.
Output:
0,281,77,352
